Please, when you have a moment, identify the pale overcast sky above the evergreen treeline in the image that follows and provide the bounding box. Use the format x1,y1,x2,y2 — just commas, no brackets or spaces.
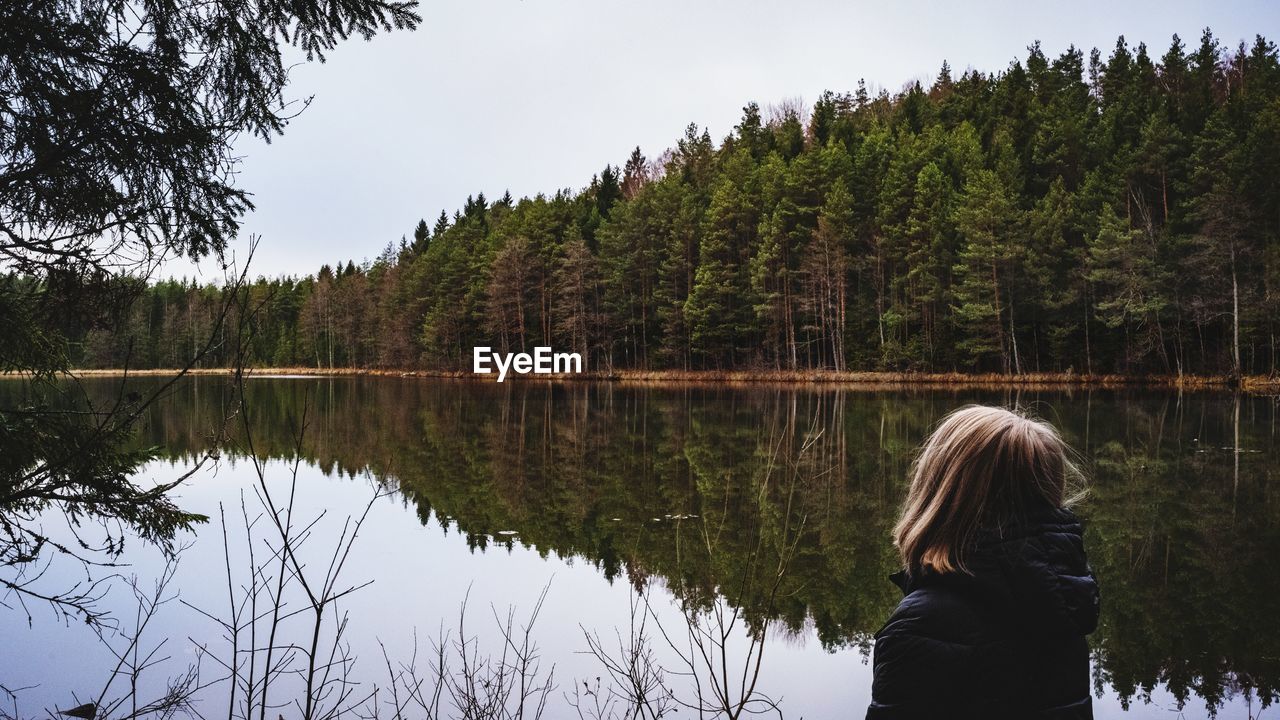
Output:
180,0,1280,281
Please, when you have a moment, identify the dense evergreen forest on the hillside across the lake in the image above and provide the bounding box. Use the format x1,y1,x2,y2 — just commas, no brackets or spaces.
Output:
45,29,1280,374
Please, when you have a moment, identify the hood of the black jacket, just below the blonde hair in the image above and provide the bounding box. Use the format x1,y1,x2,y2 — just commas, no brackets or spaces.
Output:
892,507,1100,635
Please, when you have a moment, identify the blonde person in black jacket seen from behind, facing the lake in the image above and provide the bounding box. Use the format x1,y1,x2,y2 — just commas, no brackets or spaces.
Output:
867,405,1098,720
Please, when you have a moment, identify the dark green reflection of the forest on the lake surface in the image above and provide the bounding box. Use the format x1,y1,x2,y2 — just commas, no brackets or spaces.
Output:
12,378,1280,710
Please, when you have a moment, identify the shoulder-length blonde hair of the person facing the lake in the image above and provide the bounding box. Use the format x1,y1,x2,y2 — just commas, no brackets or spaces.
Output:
893,405,1083,573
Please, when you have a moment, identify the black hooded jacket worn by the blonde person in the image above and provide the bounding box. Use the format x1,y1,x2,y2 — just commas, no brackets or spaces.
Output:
867,509,1098,720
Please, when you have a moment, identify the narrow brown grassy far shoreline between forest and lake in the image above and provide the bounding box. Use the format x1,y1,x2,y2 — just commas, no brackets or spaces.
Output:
20,368,1280,393
